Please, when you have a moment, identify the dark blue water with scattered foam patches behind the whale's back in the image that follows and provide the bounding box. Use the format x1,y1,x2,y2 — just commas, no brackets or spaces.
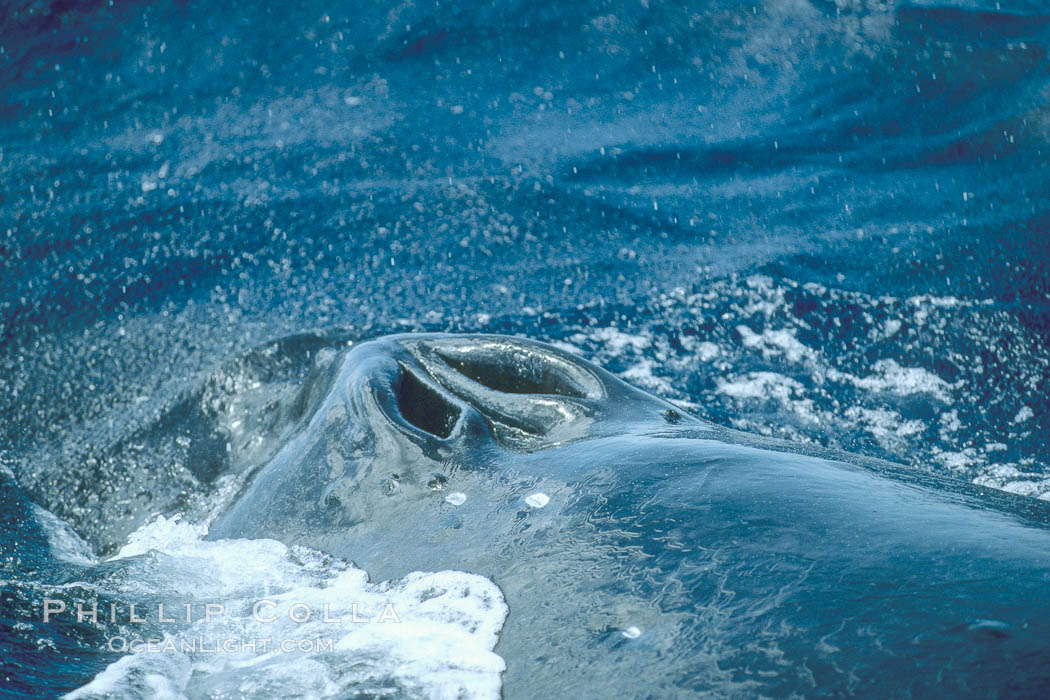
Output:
554,275,1050,497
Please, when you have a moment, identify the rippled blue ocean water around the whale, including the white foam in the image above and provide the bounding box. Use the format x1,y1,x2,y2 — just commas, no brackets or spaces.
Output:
0,0,1050,697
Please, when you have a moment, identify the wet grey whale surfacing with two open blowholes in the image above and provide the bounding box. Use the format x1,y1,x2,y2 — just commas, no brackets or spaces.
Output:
209,334,1050,698
